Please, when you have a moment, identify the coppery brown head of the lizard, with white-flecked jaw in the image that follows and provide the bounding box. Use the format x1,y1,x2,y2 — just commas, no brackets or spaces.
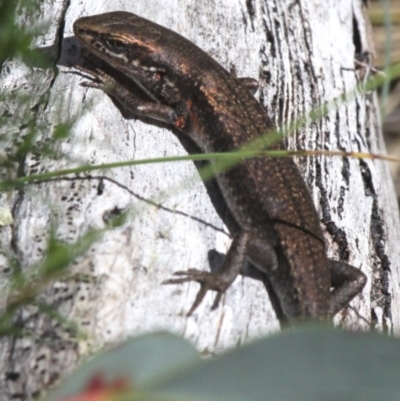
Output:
74,11,200,92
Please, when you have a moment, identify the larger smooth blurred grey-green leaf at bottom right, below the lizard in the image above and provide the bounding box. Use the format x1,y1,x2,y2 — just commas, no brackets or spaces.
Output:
157,329,400,401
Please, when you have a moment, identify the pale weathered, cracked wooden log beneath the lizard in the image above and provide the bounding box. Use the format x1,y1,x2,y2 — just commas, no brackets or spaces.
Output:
0,0,400,400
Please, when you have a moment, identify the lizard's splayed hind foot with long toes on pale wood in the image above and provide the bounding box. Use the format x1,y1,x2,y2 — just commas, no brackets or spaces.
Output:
162,269,229,316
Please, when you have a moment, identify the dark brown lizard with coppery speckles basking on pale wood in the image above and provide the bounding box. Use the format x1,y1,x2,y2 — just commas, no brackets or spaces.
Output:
74,12,366,319
